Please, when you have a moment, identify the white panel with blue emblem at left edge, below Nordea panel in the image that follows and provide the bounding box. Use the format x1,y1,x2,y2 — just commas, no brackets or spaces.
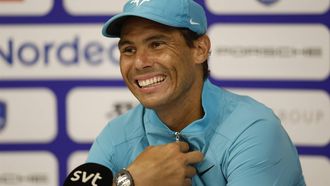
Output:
0,88,57,144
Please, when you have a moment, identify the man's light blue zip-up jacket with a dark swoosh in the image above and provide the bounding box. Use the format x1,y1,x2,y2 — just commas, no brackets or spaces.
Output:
87,80,305,186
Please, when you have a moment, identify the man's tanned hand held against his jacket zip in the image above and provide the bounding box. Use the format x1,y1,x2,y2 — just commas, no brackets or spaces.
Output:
127,141,203,186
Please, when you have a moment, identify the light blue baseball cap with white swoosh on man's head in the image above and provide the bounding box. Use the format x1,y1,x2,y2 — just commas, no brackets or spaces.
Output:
102,0,207,37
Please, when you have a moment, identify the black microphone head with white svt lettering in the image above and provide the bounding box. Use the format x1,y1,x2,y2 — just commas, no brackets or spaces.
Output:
63,163,113,186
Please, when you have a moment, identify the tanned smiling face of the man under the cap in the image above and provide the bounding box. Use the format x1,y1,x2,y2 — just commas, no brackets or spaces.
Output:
118,18,202,110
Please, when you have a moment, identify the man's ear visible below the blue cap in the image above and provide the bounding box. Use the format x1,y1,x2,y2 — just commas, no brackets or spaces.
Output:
194,35,211,64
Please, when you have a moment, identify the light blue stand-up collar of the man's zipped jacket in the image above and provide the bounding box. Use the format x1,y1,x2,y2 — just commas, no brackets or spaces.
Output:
144,80,222,153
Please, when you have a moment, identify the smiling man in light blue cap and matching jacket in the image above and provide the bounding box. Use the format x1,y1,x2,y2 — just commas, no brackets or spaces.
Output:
88,0,305,186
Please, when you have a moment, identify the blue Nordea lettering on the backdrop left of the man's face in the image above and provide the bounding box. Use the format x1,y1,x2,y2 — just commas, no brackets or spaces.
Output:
0,37,118,67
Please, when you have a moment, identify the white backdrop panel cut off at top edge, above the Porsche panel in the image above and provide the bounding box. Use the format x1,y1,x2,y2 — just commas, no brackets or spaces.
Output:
205,0,330,14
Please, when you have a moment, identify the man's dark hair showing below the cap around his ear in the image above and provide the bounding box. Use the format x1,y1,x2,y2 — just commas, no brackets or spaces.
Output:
180,28,210,80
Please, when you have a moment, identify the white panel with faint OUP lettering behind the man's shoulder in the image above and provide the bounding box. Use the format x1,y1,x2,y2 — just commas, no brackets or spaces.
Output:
233,89,330,146
